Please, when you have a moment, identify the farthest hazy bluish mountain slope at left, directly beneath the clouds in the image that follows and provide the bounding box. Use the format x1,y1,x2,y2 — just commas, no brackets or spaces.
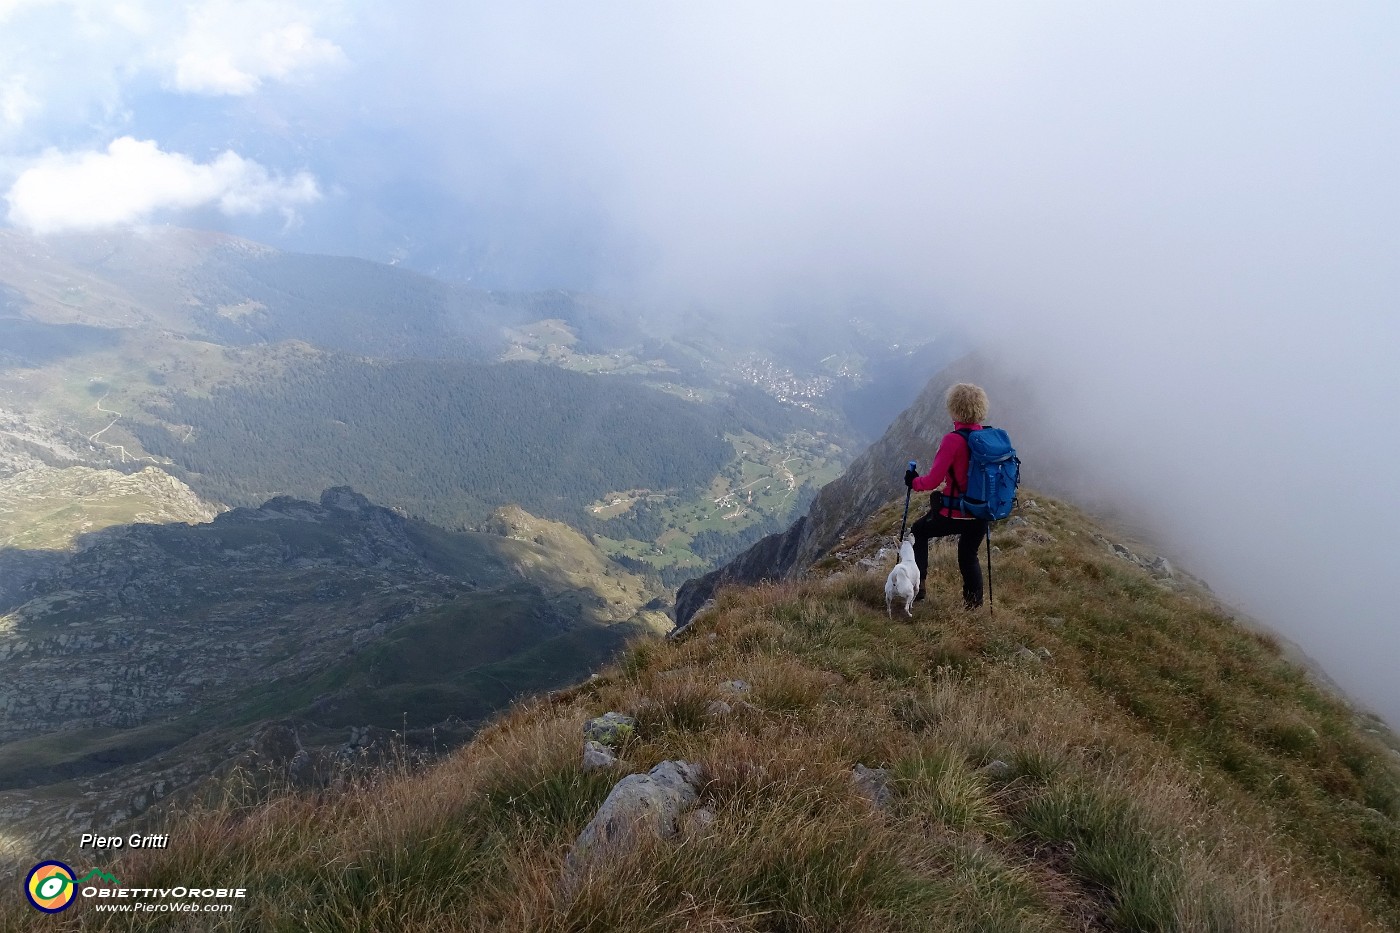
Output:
0,227,554,359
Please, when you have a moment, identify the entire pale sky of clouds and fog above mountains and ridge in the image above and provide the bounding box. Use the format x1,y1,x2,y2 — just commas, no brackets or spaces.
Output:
0,0,1400,724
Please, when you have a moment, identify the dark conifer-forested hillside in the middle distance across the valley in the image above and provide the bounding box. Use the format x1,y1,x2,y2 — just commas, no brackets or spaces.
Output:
133,360,734,527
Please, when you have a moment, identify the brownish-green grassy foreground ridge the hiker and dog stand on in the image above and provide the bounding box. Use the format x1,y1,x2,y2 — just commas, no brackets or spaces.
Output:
24,490,1400,933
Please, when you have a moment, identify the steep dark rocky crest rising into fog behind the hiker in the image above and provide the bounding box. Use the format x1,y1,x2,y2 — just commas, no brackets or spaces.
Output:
676,357,1035,626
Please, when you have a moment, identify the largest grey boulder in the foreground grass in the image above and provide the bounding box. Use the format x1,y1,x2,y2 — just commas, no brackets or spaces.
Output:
567,761,703,881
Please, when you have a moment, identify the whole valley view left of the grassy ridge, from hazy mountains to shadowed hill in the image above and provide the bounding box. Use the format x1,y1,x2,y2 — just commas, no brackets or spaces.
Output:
0,228,952,869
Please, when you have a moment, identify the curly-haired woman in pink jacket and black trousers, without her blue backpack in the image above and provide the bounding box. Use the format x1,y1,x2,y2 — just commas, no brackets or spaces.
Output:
904,382,987,609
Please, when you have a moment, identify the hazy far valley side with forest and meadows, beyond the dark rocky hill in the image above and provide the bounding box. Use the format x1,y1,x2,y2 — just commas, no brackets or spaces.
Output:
0,227,851,581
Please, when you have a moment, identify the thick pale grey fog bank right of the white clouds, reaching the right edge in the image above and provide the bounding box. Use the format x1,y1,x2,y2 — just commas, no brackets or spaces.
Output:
369,3,1400,723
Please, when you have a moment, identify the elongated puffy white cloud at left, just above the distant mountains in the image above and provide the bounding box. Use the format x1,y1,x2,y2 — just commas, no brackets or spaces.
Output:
6,136,321,234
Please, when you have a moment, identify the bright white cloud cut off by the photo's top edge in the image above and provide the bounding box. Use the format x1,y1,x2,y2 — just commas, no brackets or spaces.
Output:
169,0,344,95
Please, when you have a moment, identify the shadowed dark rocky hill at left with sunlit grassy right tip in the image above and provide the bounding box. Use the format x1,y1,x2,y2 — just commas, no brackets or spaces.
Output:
0,487,669,869
